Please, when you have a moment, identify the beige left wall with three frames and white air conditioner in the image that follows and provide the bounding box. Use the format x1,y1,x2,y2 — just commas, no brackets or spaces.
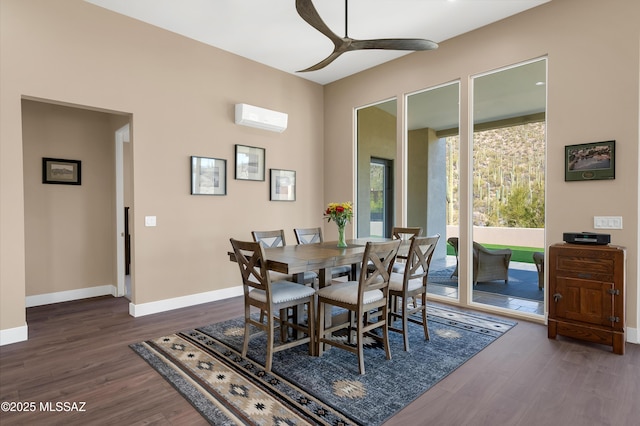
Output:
0,0,324,331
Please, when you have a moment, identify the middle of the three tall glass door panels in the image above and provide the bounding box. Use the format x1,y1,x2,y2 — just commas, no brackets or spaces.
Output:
406,82,460,299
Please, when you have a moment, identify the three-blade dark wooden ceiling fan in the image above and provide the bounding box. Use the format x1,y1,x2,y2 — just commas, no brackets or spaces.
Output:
296,0,438,72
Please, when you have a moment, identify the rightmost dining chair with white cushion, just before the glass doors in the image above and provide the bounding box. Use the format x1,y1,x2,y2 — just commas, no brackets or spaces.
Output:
389,234,440,351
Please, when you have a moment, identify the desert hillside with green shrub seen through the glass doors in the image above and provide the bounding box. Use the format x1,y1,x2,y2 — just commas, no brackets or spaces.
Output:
447,122,545,228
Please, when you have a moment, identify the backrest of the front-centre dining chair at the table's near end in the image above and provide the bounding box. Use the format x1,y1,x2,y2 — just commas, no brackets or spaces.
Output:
358,240,401,303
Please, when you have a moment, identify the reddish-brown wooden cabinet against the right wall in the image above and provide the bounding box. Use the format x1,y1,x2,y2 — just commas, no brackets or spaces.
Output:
548,243,626,355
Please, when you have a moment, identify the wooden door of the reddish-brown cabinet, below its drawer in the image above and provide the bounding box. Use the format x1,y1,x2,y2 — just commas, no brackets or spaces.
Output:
550,277,614,327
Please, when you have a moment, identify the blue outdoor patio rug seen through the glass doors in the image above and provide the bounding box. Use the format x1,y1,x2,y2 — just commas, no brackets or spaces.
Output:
428,266,544,301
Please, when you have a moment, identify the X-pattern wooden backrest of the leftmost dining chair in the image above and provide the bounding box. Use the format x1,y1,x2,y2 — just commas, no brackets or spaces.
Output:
230,238,271,294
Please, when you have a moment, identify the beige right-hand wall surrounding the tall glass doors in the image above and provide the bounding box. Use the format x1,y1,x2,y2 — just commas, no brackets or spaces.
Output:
324,0,640,330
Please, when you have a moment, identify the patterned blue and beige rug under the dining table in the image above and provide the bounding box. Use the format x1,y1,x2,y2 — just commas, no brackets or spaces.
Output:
131,304,516,425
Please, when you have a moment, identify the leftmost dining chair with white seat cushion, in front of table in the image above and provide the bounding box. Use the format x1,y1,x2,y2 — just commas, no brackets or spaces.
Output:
230,238,316,372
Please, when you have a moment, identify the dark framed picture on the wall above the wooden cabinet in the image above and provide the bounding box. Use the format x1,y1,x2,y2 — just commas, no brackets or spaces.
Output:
564,141,616,181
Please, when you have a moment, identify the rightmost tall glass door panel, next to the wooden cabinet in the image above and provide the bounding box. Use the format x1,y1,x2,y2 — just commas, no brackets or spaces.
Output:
465,59,547,315
